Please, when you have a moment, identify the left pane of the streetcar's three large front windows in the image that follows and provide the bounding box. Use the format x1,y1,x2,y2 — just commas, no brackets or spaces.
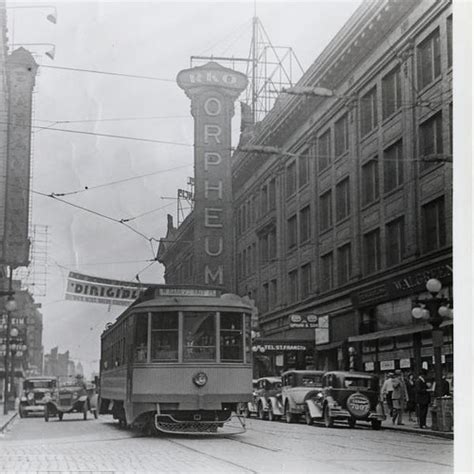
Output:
151,312,179,362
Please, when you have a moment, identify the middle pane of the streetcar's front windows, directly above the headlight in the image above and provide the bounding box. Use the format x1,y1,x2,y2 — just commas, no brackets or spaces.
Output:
183,312,216,360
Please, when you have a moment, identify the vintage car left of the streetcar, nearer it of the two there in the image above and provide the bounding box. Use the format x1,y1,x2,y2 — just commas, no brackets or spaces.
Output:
44,382,97,421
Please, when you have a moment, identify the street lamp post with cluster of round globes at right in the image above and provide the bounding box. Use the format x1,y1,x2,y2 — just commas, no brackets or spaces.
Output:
411,278,452,397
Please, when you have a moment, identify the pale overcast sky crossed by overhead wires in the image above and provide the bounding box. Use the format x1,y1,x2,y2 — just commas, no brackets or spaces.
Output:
8,0,360,373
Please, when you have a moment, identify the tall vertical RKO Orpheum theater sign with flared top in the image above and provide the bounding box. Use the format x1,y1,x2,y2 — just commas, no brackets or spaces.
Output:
177,62,247,287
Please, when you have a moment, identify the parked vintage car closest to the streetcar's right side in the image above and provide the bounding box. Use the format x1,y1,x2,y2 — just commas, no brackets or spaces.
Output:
248,377,283,421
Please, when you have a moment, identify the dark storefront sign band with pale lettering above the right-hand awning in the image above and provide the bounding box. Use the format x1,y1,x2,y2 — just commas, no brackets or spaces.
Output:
352,261,453,307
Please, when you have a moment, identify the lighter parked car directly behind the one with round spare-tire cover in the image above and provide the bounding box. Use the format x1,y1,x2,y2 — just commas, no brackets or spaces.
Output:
281,370,324,423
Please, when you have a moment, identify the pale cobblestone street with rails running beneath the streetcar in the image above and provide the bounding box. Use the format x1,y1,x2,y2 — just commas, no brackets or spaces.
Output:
0,415,453,473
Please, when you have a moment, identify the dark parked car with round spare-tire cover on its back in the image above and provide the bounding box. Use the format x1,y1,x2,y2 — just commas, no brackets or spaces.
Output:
305,371,385,430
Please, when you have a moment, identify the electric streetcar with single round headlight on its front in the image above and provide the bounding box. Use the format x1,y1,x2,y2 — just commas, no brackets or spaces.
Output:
99,285,253,434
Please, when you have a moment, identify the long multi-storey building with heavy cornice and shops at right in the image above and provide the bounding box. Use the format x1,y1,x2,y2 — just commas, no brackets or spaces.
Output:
232,0,453,375
